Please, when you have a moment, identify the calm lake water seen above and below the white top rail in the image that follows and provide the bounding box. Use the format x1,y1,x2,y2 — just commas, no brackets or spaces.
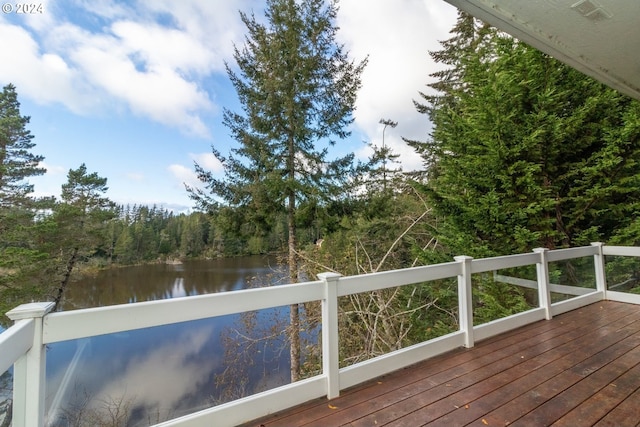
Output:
46,257,296,427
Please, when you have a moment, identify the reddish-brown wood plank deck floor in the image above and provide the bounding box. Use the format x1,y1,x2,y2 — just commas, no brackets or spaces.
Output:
246,301,640,427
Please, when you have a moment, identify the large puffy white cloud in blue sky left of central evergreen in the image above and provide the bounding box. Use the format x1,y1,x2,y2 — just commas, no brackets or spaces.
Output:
0,0,255,138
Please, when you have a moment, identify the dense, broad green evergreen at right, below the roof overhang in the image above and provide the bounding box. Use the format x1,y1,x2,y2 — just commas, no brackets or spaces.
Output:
413,16,640,256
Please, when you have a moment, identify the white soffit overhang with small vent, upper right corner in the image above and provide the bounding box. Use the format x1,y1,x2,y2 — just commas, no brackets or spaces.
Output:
445,0,640,100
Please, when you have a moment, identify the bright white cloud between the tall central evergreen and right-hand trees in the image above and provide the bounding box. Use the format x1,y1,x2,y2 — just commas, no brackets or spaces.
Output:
338,0,456,170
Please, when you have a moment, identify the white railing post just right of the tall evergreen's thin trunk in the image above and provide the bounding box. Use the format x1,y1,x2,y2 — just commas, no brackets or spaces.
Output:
318,273,342,399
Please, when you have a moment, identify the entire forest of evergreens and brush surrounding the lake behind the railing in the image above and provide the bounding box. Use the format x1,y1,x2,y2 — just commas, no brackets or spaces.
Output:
0,0,640,388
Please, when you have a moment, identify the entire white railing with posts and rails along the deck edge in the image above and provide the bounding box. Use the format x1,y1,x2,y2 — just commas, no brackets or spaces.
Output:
0,243,640,427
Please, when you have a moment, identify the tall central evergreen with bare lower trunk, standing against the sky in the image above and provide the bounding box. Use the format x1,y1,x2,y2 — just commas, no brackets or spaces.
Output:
191,0,366,380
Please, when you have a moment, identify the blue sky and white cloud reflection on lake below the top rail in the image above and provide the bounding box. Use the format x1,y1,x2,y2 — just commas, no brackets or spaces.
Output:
49,322,222,425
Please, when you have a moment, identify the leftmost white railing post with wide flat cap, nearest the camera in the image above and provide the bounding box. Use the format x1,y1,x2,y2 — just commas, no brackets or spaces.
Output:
7,302,55,427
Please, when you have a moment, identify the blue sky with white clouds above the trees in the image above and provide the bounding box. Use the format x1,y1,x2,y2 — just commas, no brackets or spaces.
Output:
0,0,457,212
